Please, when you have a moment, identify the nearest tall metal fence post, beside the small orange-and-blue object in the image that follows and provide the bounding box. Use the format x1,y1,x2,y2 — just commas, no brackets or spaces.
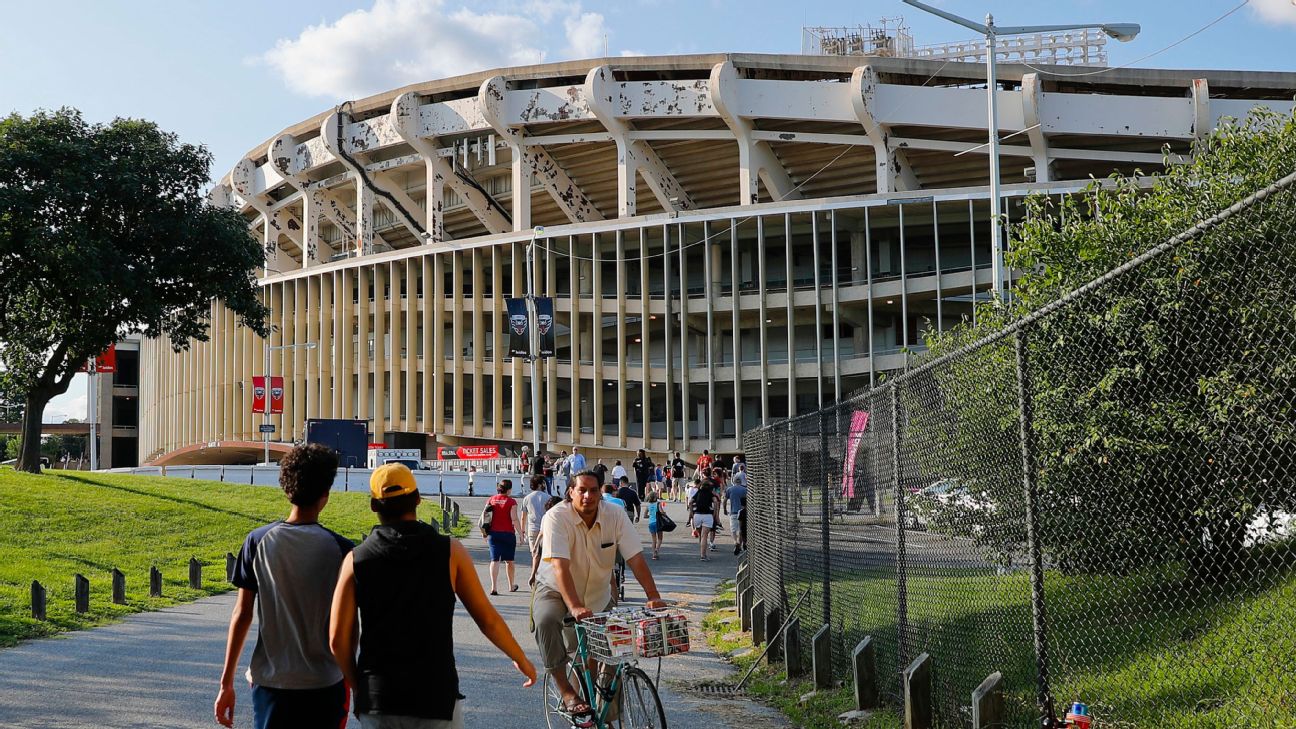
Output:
1013,328,1056,726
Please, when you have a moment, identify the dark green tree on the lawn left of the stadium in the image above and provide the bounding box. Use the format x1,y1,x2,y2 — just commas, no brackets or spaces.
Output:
0,109,267,472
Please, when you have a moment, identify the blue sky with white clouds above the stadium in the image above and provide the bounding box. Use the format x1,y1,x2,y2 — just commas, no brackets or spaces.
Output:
0,0,1296,422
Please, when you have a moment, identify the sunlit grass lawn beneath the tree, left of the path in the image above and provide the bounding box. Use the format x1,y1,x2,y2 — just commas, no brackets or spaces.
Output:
0,468,469,646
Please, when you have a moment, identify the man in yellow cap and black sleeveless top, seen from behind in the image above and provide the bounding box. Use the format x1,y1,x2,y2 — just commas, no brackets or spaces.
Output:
334,463,535,729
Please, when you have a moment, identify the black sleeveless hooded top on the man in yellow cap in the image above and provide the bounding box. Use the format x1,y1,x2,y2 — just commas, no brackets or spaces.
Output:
353,521,460,721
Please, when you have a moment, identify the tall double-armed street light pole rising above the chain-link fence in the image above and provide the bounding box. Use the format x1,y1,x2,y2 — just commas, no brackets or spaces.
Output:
901,0,1142,301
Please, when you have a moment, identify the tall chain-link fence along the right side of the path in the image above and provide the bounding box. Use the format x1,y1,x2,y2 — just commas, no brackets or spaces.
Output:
745,167,1296,728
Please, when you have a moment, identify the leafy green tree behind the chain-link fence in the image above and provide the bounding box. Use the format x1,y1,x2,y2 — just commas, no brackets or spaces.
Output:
929,110,1296,579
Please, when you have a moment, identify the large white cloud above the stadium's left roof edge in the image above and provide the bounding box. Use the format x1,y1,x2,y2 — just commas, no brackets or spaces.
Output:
260,0,546,99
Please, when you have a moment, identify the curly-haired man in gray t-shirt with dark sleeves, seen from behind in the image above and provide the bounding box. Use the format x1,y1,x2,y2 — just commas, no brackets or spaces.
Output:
215,444,352,729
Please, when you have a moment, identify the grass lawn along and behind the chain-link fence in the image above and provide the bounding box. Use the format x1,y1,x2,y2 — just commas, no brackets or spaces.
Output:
706,554,1296,729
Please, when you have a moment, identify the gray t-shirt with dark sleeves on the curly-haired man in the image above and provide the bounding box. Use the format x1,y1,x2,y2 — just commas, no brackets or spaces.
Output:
233,521,354,689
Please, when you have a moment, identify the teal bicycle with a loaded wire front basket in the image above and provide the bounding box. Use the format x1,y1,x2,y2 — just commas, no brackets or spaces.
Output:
543,607,688,729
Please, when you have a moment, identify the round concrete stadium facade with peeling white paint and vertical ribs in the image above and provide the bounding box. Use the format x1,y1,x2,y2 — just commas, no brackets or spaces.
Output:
139,54,1296,463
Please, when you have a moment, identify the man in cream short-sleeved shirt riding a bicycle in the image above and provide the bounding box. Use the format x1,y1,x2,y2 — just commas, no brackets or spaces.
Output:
531,471,666,719
